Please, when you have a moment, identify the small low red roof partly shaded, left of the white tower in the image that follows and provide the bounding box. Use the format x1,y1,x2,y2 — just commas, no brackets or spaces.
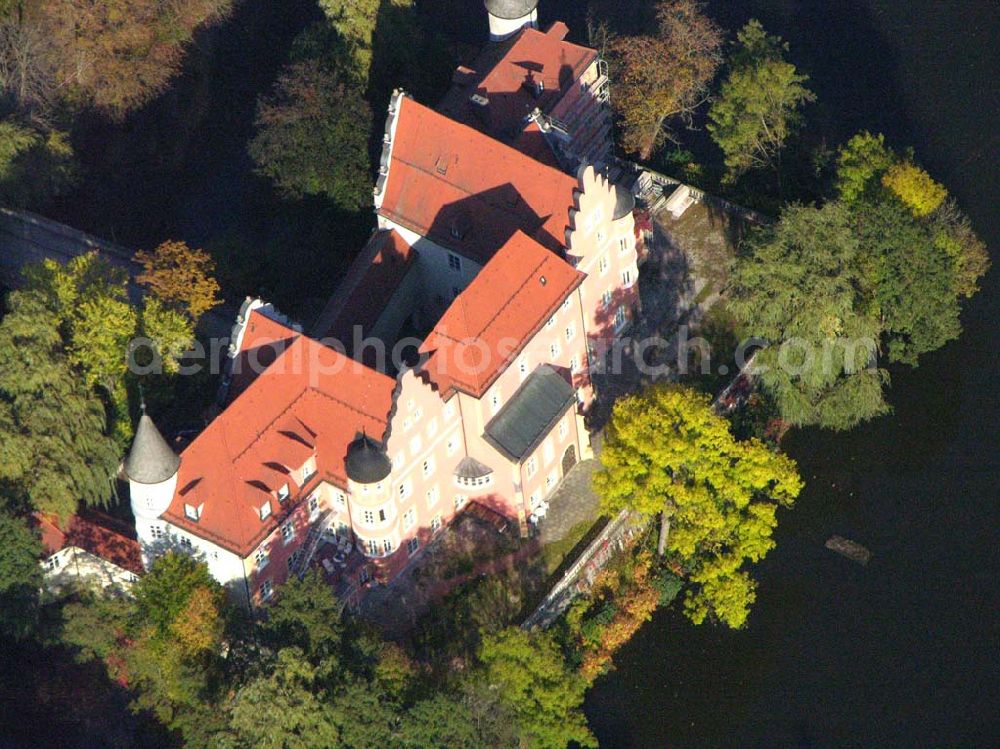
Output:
35,511,143,575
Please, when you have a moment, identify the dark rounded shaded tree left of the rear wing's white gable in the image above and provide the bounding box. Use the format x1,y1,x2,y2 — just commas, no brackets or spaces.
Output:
249,60,372,211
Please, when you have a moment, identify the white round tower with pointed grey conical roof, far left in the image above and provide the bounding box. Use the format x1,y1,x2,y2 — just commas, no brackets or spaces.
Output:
125,406,181,564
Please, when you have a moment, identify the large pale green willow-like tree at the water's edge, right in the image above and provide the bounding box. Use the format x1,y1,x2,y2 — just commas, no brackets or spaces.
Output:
727,203,889,429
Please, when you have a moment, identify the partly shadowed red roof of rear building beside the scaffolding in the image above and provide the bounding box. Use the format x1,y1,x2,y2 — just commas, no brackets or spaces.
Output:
439,22,597,163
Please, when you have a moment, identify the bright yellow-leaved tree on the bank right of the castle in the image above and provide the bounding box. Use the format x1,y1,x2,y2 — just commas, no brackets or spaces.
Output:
594,386,802,628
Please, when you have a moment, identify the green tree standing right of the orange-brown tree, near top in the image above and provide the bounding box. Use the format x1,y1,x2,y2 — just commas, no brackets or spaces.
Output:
708,20,816,179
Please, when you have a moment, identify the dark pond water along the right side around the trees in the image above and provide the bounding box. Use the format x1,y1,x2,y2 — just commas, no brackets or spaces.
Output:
587,0,1000,749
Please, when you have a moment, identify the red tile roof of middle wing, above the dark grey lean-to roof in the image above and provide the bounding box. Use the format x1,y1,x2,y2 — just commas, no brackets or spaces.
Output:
420,232,585,398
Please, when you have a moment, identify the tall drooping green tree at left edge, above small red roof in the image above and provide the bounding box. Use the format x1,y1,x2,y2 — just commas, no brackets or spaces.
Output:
0,291,118,519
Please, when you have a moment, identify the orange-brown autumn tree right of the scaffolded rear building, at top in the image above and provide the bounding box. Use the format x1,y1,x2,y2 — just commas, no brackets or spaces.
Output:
609,0,722,159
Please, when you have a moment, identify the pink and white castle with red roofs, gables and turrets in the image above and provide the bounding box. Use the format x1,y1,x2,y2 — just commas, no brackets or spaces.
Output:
125,11,638,604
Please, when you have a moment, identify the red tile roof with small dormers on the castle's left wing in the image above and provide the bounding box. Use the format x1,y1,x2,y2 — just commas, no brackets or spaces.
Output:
163,336,396,556
